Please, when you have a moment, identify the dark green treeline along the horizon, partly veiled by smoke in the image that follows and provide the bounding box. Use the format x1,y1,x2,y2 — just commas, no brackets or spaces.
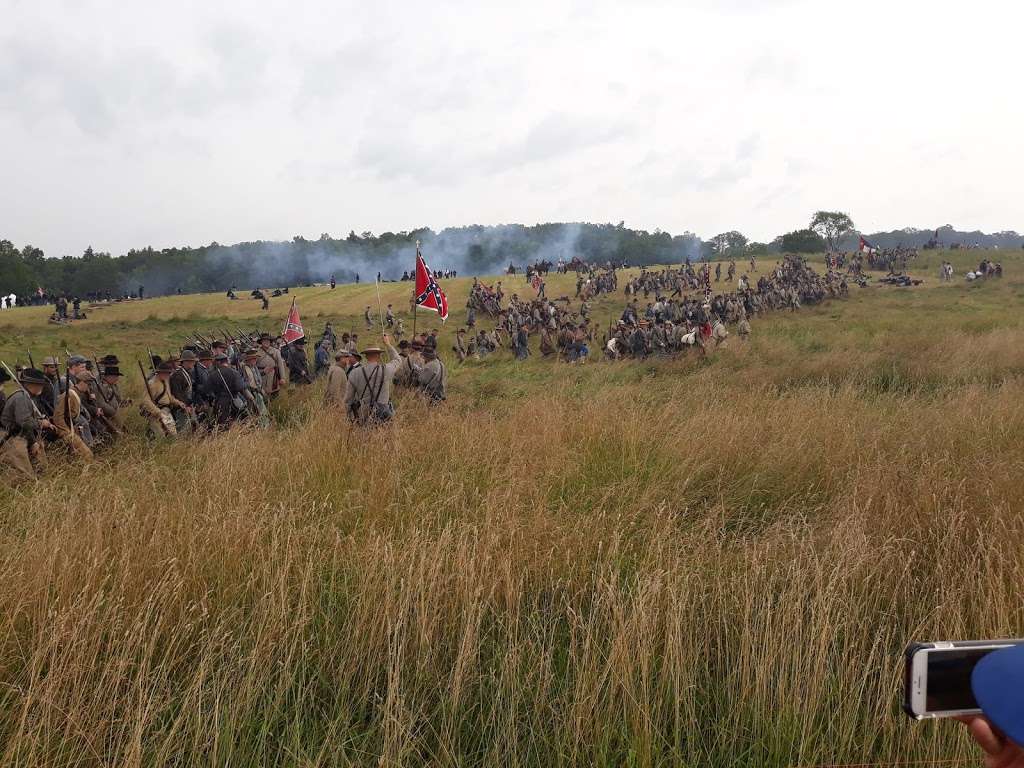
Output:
0,222,1024,296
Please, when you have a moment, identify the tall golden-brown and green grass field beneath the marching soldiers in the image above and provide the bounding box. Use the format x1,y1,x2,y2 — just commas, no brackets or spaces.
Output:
0,253,1024,766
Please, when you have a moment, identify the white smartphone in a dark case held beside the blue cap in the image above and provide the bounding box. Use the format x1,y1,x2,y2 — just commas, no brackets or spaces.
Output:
903,639,1024,720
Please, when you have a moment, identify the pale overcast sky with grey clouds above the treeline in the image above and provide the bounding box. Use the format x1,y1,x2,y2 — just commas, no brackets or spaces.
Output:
0,0,1024,256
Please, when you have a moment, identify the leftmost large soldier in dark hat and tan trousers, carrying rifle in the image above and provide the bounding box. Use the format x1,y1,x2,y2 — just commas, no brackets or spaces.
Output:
0,368,53,480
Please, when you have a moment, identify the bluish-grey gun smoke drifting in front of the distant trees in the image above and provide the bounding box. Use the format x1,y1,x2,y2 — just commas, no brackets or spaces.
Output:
122,223,700,295
